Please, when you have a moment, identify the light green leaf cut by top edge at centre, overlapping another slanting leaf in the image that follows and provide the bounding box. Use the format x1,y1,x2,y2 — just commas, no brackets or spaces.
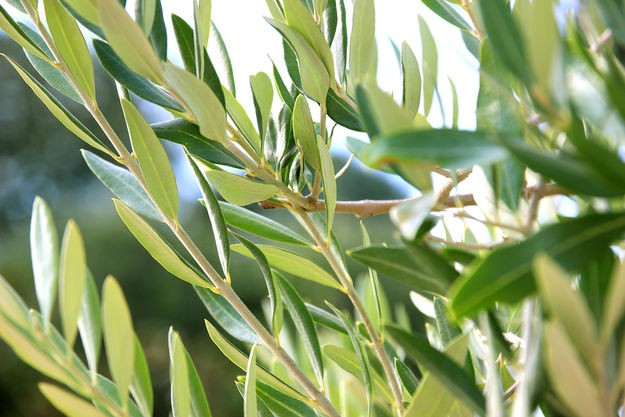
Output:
283,0,334,78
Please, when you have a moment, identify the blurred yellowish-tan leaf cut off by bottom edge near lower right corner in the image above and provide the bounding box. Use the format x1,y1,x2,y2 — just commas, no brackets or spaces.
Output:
544,321,603,417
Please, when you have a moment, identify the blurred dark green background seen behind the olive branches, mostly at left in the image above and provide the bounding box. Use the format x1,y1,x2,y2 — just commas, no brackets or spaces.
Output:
0,32,414,417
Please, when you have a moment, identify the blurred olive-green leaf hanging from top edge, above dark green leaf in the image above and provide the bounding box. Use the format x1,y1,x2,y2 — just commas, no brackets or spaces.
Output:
98,0,164,84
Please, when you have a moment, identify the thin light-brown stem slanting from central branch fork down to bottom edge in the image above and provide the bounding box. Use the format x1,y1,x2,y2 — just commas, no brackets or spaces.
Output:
293,207,404,416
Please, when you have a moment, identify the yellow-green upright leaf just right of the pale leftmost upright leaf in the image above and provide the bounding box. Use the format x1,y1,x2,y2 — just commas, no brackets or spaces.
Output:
59,220,87,346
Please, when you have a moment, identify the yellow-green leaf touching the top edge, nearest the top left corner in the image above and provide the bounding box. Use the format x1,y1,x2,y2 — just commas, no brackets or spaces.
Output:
43,0,95,101
